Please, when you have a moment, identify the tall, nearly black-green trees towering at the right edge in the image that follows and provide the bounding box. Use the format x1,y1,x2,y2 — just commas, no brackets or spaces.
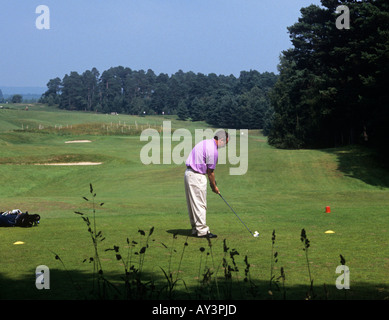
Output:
269,0,389,149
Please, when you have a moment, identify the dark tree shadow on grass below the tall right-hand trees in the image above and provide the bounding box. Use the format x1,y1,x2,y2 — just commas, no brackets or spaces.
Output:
322,146,389,188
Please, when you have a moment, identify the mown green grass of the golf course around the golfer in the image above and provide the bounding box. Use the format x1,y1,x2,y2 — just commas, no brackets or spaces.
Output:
0,105,389,299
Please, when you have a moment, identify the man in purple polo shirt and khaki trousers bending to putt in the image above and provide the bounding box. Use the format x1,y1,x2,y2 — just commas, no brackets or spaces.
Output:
184,130,229,238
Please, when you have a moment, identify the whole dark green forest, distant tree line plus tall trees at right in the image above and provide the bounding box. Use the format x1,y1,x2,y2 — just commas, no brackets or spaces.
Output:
41,0,389,150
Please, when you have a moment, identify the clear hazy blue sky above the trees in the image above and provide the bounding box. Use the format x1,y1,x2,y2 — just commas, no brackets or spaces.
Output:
0,0,320,88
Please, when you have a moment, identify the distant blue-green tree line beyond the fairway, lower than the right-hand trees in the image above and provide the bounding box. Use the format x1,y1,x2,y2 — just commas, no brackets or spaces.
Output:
40,66,277,130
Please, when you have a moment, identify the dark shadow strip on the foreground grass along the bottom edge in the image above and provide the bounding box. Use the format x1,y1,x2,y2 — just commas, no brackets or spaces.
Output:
0,269,389,301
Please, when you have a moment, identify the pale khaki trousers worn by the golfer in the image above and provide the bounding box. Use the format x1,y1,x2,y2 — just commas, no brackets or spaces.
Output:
184,169,209,236
